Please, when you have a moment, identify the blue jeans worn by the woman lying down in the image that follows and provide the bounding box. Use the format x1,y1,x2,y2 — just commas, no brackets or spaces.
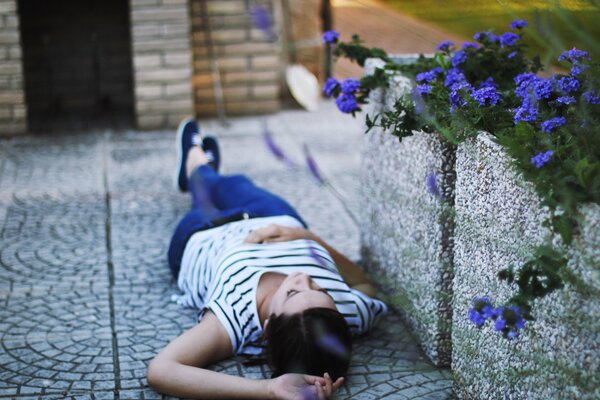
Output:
168,165,307,278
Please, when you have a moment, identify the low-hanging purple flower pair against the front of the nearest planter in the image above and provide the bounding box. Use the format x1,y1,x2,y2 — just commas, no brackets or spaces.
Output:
469,297,525,339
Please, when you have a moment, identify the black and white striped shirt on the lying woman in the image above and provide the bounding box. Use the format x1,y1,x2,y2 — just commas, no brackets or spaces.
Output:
173,216,387,354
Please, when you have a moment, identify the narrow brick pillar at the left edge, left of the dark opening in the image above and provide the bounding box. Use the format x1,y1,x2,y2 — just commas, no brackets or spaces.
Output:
0,0,27,134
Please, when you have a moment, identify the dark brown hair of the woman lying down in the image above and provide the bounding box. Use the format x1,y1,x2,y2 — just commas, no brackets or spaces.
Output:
266,307,352,381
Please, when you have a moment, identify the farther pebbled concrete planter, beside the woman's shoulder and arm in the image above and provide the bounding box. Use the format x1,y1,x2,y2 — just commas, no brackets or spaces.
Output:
360,60,455,365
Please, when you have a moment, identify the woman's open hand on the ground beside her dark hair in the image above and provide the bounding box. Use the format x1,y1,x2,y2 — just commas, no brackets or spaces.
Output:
269,373,344,400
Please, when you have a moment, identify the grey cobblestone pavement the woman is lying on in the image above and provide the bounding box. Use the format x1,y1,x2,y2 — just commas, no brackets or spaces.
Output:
0,103,452,399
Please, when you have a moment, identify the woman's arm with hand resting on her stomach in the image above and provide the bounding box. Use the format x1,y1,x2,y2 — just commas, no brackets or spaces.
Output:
245,224,376,297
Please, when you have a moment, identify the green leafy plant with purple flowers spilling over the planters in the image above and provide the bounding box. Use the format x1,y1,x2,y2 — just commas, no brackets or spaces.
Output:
324,20,600,339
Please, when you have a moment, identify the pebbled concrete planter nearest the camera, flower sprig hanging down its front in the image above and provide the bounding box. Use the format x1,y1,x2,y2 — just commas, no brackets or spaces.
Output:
452,134,600,400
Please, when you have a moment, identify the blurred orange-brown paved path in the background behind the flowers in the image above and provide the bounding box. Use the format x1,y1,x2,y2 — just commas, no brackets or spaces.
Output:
331,0,468,79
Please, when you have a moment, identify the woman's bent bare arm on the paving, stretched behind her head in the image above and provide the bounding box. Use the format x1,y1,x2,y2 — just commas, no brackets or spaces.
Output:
147,311,342,399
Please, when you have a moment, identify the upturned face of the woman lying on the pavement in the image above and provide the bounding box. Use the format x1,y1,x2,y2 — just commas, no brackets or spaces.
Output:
269,272,336,315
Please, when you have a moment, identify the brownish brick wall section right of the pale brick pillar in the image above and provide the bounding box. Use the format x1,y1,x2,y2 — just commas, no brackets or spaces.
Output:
191,0,281,117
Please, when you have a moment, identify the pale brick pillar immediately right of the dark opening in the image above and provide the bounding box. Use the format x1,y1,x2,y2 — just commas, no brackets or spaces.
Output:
130,0,193,129
